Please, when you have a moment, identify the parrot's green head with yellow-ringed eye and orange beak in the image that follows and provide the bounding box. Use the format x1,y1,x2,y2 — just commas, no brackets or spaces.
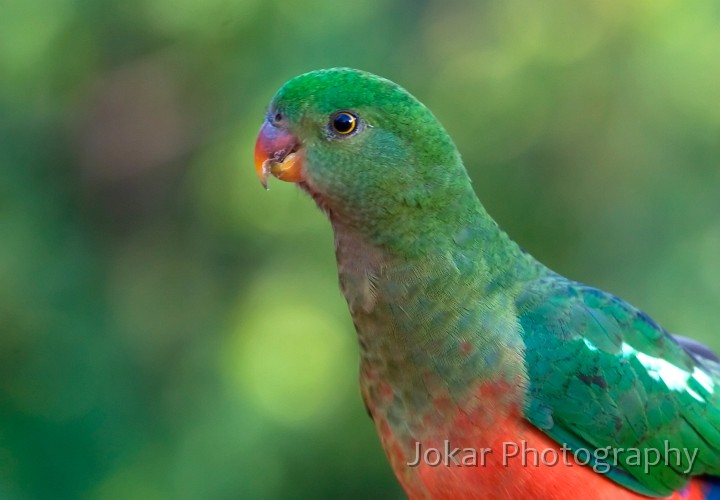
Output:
255,68,475,250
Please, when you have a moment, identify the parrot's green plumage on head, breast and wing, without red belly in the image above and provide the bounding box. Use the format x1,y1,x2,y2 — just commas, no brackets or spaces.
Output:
256,69,720,496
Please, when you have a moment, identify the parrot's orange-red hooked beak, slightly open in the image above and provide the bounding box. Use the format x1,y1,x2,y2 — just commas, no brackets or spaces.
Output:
255,120,305,189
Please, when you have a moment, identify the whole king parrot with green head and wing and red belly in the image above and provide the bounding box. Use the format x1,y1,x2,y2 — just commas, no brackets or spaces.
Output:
255,68,720,499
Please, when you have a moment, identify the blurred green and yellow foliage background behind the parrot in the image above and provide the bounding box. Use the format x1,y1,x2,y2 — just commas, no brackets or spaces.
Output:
0,0,720,499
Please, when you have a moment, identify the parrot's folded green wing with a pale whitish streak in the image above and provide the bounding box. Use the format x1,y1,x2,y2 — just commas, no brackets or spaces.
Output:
517,275,720,496
